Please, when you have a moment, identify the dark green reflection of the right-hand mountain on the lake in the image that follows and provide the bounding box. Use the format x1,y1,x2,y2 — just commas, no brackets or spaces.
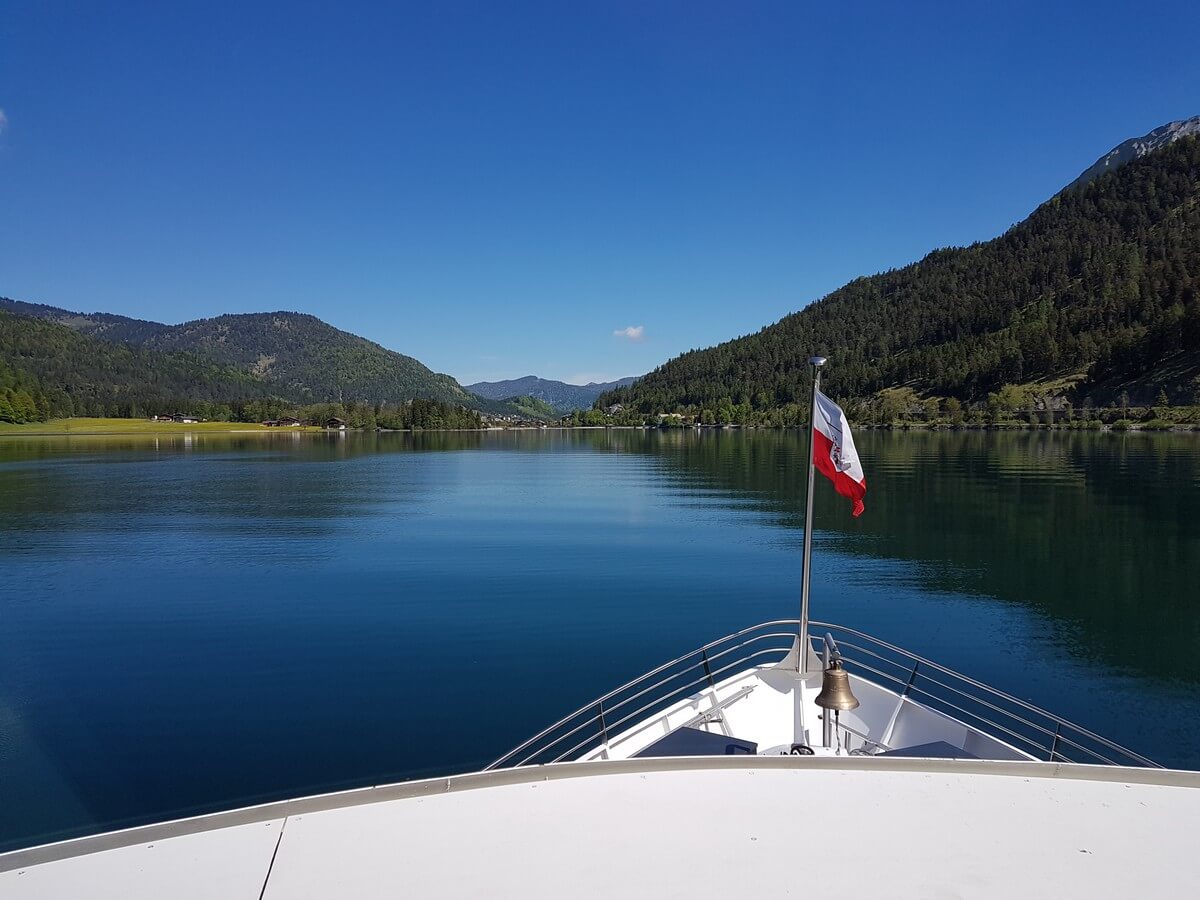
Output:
549,431,1200,682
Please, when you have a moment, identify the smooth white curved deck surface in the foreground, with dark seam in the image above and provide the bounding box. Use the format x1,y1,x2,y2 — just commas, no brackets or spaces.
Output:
0,757,1200,900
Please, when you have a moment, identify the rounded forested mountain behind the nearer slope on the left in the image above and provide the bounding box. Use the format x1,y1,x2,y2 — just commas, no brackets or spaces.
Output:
0,299,482,407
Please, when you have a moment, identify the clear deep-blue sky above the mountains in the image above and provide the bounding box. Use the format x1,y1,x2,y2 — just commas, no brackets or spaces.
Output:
0,0,1200,383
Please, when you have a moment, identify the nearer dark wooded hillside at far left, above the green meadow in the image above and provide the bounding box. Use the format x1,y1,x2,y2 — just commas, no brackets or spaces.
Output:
0,311,271,422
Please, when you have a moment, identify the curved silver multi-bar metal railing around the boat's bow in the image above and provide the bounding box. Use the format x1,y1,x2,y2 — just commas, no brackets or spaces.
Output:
487,619,1162,769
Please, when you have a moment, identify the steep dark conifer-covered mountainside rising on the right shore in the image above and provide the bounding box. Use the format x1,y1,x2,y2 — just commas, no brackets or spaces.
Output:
598,131,1200,413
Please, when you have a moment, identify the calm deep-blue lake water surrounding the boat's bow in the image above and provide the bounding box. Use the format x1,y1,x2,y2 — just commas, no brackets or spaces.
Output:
0,431,1200,848
